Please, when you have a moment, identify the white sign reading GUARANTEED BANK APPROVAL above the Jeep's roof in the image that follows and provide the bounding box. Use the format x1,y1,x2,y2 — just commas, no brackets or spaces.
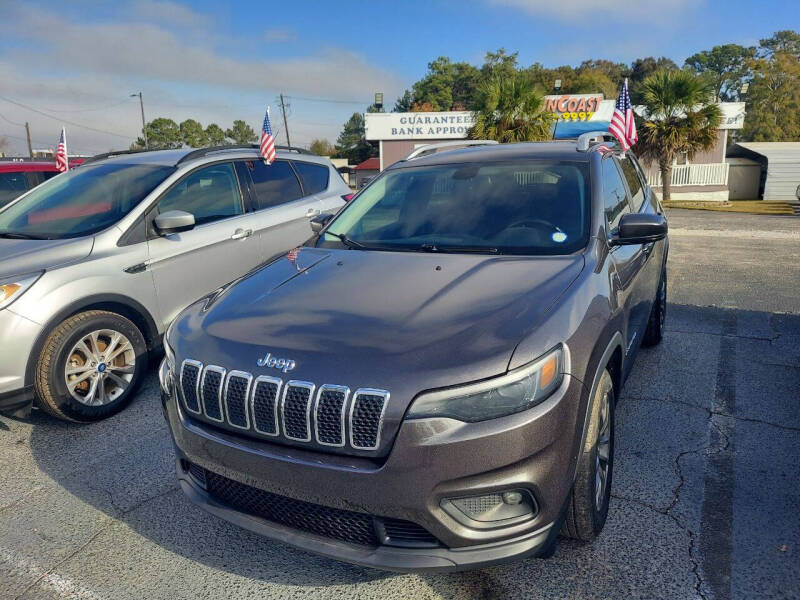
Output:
364,110,475,140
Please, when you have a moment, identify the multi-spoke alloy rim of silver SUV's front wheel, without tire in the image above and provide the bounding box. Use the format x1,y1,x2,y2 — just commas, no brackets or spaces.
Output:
64,329,136,406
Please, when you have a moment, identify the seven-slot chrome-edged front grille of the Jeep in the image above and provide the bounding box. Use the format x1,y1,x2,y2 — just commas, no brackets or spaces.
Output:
179,359,389,450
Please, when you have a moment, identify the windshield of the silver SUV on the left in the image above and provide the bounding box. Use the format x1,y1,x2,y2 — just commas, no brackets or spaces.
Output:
0,163,175,239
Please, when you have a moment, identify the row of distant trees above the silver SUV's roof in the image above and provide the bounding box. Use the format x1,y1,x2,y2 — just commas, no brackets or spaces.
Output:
131,117,258,150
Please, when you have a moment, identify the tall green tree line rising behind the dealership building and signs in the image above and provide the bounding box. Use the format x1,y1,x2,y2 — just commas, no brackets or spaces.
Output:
335,30,800,162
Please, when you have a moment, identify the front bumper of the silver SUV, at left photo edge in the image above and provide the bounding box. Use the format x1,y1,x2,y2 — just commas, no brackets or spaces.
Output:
0,308,42,412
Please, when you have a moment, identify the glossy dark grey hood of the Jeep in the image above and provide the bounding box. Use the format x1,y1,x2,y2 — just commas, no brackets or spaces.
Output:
170,248,584,404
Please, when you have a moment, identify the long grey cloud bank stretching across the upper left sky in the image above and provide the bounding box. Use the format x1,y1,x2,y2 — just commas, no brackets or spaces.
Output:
0,11,400,99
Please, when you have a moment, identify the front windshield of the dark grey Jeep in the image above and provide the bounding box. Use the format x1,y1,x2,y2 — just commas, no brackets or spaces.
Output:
318,161,589,255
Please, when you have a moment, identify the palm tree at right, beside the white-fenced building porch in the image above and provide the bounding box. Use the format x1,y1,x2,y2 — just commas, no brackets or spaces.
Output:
636,70,722,202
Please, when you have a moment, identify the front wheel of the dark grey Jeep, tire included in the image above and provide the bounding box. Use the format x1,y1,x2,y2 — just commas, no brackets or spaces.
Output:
561,370,614,542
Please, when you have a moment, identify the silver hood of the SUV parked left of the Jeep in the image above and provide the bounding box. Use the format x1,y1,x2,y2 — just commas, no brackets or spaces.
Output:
0,237,94,279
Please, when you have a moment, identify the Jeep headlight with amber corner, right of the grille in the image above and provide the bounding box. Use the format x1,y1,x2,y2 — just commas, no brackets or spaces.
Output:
406,346,564,423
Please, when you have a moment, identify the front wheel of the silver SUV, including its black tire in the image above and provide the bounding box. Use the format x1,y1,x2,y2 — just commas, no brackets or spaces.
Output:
34,310,148,423
